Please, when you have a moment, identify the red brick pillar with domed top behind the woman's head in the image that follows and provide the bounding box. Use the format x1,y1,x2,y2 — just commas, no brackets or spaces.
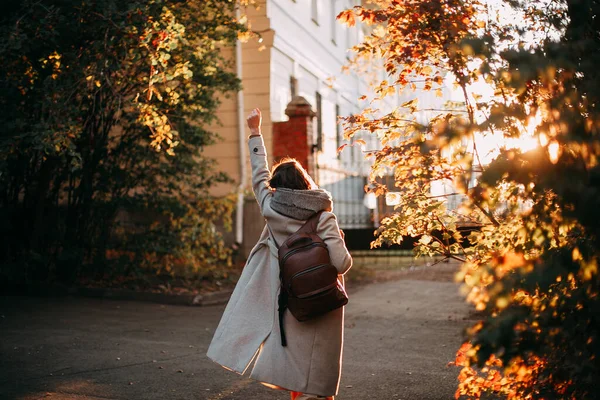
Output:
273,96,316,175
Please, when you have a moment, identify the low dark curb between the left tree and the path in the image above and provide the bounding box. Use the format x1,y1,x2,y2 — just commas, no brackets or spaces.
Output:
3,285,233,307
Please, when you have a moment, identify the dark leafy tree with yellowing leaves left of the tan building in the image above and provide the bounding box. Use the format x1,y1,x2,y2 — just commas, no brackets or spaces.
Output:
0,0,245,283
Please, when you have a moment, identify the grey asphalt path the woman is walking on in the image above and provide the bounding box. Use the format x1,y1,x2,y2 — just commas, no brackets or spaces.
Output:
0,265,471,400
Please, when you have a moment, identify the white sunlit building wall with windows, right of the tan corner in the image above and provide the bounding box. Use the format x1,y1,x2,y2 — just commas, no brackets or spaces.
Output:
267,0,380,229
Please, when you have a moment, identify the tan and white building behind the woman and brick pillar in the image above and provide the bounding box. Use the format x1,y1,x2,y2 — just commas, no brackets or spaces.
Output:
206,0,406,254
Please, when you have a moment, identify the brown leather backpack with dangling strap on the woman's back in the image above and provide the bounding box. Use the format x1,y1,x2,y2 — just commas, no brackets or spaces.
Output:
271,211,348,346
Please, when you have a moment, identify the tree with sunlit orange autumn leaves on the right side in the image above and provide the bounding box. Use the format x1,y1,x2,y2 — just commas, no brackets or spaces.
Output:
338,0,600,399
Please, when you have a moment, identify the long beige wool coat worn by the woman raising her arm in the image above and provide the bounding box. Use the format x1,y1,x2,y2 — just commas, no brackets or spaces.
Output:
207,136,352,396
